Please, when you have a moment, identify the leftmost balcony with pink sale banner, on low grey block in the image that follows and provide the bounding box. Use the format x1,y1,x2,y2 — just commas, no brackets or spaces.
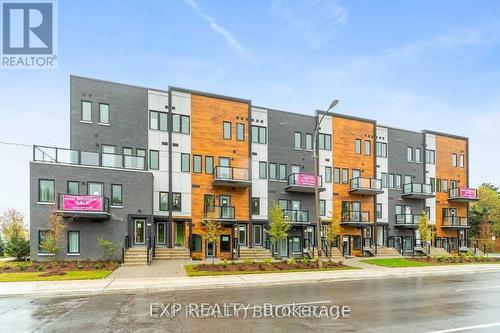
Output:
57,194,111,220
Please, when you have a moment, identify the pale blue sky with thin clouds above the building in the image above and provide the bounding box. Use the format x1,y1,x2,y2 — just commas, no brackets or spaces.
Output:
0,0,500,220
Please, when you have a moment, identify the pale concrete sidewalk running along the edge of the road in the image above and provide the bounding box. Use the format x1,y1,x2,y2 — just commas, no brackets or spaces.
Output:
0,264,500,297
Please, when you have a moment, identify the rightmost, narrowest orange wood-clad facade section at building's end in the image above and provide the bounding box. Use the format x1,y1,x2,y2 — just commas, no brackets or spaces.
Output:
436,135,469,237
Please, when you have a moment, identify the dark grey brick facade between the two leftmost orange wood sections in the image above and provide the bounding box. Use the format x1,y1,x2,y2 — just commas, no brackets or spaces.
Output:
268,110,316,223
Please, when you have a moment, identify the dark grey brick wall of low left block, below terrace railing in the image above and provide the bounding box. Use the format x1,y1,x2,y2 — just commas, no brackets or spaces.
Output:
30,162,153,260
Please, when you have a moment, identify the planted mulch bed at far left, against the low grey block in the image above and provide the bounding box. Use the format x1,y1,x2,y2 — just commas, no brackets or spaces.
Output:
0,261,119,276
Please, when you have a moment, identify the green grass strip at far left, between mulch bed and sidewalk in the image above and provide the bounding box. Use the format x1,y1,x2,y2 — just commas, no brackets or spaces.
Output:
0,269,112,282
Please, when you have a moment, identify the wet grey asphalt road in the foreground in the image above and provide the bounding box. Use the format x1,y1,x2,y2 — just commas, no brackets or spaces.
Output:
0,273,500,333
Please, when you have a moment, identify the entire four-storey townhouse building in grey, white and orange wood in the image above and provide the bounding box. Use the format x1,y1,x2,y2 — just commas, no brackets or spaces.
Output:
30,76,477,263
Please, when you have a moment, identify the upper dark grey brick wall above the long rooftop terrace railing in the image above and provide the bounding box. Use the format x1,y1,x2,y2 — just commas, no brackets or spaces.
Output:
70,76,148,153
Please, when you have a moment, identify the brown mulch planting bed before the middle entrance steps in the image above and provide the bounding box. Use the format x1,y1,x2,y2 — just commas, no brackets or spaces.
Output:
193,261,346,272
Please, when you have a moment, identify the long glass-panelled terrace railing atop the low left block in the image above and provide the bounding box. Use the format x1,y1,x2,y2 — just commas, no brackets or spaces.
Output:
33,146,147,170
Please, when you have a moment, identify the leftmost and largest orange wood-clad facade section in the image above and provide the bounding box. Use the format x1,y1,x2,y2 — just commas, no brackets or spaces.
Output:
191,94,250,258
